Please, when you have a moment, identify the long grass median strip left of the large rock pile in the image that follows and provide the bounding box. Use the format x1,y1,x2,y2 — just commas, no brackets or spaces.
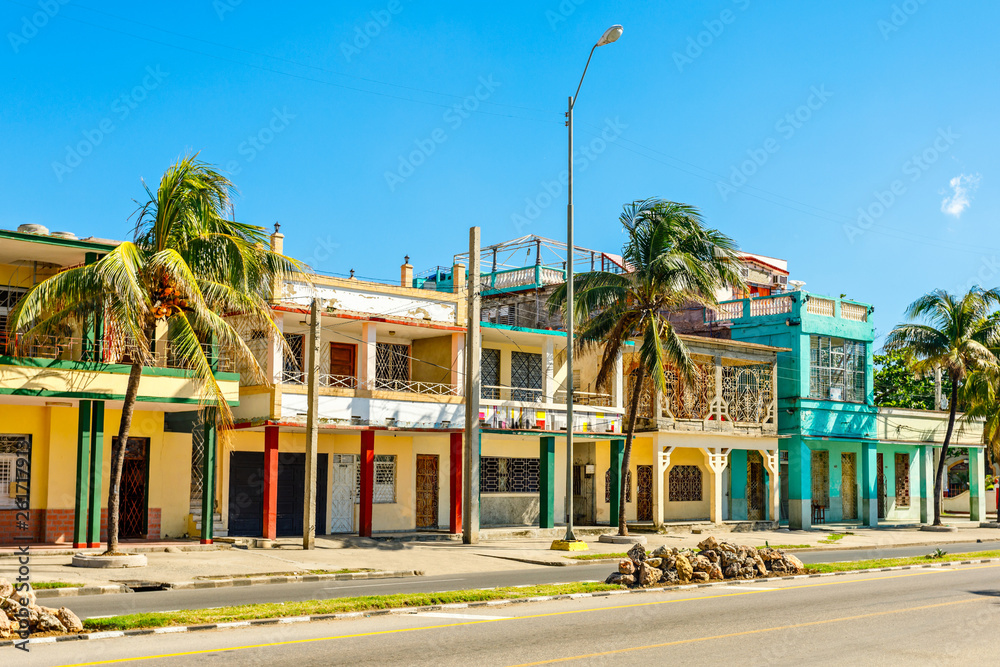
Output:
83,582,620,632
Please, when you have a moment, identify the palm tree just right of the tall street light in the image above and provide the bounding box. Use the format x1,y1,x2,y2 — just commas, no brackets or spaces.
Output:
549,199,743,535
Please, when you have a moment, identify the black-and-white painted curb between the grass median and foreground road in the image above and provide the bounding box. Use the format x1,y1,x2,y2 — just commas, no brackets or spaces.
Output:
9,558,1000,648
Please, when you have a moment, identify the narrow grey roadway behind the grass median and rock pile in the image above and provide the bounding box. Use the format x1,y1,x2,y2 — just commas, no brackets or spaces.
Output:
60,542,1000,618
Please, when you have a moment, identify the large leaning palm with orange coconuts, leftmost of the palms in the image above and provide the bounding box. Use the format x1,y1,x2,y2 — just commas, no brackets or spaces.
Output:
9,155,298,553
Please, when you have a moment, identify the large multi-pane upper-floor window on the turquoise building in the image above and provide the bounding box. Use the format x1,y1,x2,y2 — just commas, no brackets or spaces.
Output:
809,336,868,403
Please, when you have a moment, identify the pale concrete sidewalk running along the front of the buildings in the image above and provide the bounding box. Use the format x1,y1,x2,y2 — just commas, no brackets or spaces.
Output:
0,521,1000,586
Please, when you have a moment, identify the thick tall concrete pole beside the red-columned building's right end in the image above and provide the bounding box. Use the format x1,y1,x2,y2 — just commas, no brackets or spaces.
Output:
462,227,482,544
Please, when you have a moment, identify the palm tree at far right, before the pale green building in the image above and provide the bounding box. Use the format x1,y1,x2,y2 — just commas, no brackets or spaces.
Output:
884,287,1000,526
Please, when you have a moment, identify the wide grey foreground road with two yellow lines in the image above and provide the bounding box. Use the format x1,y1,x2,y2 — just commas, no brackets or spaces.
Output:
15,564,1000,667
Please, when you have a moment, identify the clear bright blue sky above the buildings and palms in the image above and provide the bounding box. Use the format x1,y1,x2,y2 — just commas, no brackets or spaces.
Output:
0,0,1000,334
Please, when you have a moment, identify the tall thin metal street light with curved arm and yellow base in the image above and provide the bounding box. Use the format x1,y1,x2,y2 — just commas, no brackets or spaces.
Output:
566,25,622,542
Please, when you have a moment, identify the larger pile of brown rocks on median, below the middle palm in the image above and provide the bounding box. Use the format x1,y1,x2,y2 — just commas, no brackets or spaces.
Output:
605,537,805,588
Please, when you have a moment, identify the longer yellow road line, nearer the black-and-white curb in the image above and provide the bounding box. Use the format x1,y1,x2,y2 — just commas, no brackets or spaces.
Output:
58,564,1000,667
